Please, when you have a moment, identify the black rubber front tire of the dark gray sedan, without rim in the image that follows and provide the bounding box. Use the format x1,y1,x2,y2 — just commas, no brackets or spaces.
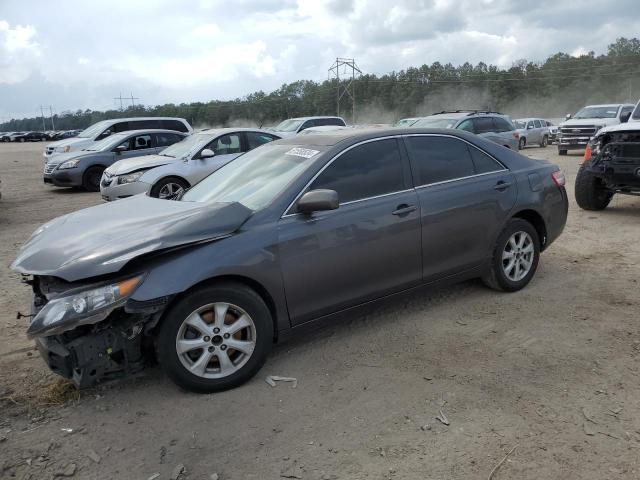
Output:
155,282,273,393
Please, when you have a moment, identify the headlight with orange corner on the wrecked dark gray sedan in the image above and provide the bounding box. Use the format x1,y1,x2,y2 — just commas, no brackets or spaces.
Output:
27,275,144,338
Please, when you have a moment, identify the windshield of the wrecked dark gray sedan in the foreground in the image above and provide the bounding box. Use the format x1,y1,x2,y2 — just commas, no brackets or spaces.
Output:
182,145,320,211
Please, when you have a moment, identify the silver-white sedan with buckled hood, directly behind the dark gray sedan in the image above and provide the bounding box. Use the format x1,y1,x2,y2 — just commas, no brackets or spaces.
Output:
100,128,280,201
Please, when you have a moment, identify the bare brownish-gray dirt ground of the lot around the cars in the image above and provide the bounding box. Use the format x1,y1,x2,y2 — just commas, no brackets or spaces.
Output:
0,143,640,480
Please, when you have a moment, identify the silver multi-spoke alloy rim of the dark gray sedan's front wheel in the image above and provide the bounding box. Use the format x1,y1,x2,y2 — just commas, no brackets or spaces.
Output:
176,302,256,379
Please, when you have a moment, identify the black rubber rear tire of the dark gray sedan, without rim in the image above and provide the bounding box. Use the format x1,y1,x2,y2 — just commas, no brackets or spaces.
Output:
482,218,540,292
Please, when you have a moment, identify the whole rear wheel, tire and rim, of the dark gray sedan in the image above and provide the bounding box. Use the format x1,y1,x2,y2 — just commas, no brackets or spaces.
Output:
482,218,540,292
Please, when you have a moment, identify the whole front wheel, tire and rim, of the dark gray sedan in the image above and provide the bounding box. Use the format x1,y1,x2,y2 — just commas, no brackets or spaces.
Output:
156,283,273,393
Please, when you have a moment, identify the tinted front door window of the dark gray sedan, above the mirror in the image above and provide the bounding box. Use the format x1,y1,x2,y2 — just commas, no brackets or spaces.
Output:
309,138,405,204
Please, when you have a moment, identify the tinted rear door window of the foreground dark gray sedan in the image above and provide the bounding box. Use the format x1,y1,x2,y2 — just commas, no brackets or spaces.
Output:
406,137,476,185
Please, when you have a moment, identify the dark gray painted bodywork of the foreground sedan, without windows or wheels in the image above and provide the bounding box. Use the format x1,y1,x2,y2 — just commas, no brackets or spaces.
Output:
12,128,568,338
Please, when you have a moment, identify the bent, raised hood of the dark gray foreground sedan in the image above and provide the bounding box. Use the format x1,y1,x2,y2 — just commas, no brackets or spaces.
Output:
11,195,252,282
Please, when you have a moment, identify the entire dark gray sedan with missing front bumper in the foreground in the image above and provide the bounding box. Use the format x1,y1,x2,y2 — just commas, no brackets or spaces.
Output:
12,128,568,392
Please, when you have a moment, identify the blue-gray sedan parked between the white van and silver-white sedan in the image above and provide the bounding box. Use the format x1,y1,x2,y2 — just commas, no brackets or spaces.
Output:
43,130,186,192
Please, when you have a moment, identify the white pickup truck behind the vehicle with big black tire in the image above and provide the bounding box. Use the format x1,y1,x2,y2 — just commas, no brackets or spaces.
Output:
558,103,635,155
